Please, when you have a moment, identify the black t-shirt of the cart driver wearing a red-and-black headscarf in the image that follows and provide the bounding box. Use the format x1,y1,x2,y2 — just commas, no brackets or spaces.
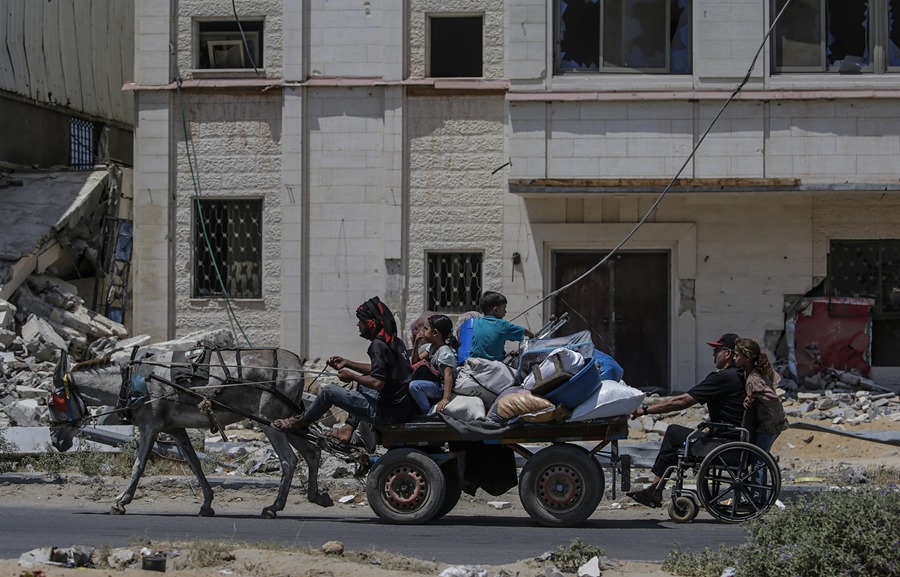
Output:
367,338,412,423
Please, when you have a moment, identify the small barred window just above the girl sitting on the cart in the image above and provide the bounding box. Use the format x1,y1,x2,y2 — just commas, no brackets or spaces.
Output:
425,252,483,313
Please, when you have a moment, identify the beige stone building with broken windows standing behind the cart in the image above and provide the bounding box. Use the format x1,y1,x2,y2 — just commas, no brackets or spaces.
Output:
123,0,900,390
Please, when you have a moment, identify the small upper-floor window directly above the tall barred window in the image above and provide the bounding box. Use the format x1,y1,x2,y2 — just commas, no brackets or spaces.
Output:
196,20,263,69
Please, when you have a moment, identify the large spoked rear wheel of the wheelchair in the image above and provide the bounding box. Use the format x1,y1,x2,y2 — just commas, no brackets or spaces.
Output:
697,442,781,523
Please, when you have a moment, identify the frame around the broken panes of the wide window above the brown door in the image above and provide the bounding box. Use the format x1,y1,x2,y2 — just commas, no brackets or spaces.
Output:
553,0,694,76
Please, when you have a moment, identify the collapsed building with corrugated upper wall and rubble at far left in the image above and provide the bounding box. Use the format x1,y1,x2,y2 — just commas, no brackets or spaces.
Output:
0,0,134,426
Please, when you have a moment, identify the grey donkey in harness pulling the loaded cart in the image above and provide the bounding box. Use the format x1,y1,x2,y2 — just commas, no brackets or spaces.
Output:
47,349,334,519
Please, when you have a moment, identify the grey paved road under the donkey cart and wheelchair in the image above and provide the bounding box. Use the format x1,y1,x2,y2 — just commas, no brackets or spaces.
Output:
0,498,745,565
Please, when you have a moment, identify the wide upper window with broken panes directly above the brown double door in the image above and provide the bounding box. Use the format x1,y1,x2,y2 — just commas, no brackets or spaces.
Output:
556,0,691,74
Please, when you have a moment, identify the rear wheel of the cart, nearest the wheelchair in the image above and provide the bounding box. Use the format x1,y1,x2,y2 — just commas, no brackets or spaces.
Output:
519,445,604,527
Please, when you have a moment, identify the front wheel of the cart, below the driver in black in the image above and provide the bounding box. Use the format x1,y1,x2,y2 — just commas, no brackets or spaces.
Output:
366,449,445,525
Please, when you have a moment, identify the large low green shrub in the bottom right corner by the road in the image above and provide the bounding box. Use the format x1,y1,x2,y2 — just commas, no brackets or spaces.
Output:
663,488,900,577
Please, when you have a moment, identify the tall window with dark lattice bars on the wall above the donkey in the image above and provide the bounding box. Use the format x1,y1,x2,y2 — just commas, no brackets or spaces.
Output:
193,199,262,299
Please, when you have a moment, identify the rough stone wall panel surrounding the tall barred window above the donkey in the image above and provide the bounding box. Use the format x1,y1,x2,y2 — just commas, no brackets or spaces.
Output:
173,91,283,346
